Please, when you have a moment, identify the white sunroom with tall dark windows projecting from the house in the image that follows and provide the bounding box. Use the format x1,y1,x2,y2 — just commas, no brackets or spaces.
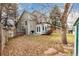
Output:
36,23,51,35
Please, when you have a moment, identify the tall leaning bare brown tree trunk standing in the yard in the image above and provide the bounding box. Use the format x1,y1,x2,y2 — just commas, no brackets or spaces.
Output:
60,3,72,44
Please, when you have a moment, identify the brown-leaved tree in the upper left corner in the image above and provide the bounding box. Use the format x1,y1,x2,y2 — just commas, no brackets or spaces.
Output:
0,3,17,27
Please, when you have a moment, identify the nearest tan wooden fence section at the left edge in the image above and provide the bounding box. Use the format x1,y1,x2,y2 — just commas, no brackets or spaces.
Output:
0,24,7,55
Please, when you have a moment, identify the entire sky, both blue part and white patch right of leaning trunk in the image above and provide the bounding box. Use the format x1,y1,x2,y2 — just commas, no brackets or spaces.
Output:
18,3,79,28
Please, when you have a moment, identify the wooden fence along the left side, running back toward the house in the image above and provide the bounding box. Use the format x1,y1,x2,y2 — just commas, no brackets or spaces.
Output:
0,24,24,55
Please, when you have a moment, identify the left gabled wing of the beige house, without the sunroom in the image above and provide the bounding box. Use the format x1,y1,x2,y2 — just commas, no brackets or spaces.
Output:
17,11,36,35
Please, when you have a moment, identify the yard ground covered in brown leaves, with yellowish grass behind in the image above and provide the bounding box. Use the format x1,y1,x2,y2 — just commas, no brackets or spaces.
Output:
3,33,74,56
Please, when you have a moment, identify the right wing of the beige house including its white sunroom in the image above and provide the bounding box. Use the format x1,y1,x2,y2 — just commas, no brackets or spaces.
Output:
32,11,52,35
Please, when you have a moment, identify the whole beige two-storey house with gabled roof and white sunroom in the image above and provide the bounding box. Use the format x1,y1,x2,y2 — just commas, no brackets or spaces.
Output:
17,11,51,35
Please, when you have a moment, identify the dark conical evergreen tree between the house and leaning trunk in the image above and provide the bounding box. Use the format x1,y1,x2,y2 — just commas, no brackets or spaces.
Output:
50,5,61,30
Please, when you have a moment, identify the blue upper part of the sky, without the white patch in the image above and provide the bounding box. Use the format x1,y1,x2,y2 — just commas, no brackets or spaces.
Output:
18,3,79,13
